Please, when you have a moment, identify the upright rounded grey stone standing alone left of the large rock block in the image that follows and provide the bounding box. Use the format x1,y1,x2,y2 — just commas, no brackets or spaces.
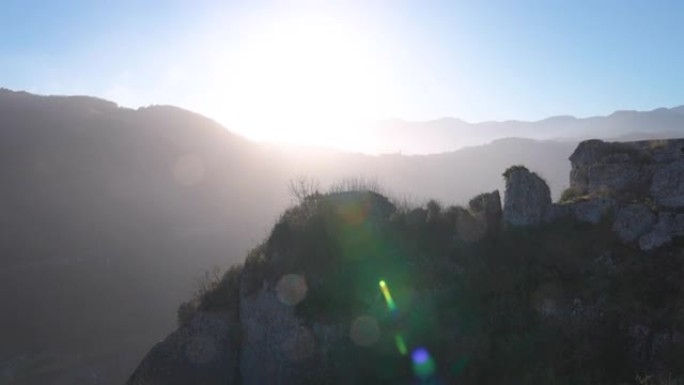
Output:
503,166,551,226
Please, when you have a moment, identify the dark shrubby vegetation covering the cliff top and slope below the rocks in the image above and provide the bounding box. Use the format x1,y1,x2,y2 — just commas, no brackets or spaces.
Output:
166,181,684,384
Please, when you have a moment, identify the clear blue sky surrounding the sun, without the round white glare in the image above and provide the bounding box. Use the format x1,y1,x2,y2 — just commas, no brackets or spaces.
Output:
0,0,684,125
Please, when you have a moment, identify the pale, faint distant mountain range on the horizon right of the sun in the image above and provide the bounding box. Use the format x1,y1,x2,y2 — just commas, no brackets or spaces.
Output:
368,106,684,154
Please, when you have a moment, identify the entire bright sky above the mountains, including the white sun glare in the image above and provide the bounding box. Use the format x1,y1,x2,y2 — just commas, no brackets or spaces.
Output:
0,0,684,146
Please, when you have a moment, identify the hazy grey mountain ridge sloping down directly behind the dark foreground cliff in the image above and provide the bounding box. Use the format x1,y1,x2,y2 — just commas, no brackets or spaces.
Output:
0,90,680,384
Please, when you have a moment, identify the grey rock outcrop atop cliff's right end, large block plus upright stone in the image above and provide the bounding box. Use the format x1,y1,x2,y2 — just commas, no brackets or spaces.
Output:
503,139,684,251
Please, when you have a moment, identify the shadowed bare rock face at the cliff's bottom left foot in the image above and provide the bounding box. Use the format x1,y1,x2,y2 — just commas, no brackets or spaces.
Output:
127,312,240,385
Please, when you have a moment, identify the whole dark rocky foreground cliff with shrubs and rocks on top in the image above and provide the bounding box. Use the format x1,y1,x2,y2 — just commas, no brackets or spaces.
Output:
129,140,684,385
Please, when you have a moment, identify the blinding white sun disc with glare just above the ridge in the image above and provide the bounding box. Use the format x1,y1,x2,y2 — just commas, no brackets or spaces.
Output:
216,16,388,147
